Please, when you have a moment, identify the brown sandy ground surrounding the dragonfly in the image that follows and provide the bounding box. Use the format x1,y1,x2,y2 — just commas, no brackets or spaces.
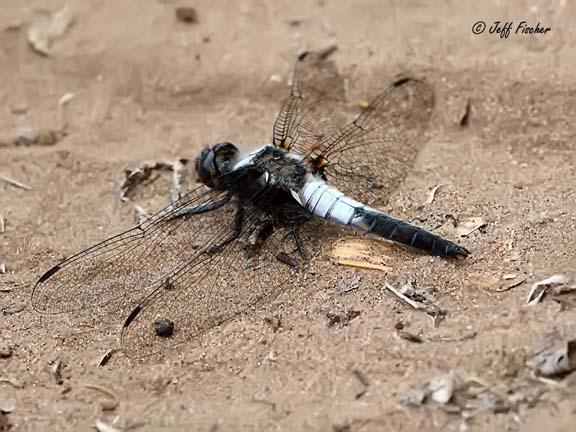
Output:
0,0,576,432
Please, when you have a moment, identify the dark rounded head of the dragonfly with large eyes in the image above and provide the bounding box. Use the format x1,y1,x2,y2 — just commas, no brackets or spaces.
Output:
196,142,240,189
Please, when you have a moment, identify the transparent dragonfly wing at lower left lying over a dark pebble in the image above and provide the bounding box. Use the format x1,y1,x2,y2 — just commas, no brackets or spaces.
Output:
122,197,324,357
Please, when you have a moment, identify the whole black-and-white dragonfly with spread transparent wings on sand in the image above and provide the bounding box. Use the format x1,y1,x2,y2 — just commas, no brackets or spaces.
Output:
32,50,470,356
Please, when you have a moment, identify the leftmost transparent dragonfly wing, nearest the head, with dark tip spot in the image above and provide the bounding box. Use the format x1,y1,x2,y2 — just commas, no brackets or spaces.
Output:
32,186,235,314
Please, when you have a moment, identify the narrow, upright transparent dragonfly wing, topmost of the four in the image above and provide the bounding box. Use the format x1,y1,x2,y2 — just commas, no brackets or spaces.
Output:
272,46,346,154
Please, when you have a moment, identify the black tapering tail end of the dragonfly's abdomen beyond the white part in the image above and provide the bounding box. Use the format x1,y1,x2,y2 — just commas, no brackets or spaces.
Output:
351,207,470,259
